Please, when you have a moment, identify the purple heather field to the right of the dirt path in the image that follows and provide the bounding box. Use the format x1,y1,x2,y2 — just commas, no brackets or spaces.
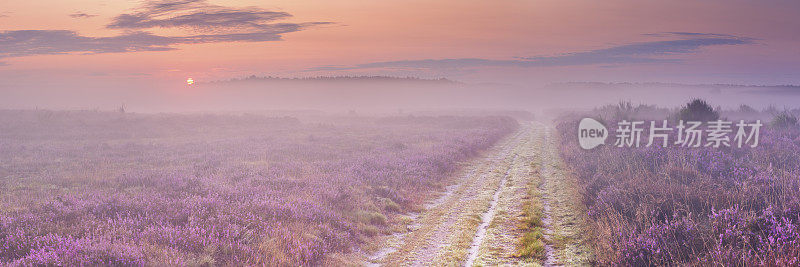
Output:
557,104,800,266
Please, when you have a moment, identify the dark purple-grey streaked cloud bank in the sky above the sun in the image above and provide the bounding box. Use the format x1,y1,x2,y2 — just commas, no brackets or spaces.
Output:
0,0,329,58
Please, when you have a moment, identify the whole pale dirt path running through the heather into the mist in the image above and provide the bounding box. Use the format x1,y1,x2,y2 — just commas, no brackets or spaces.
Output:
360,123,590,266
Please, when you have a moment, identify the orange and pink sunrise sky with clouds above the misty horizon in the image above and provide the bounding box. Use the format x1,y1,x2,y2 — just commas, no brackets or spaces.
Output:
0,0,800,110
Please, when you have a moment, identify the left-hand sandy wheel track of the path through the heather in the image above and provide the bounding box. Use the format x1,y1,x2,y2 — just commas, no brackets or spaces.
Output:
370,125,532,266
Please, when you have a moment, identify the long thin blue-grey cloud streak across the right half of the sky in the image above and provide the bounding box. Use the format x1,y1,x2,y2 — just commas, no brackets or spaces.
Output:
308,32,755,71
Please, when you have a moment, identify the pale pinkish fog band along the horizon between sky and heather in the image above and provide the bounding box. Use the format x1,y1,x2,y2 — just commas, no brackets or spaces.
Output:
0,76,800,114
